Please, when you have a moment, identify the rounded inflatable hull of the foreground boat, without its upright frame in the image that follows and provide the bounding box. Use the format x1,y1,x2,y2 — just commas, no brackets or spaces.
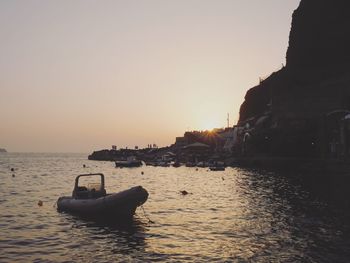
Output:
57,186,148,219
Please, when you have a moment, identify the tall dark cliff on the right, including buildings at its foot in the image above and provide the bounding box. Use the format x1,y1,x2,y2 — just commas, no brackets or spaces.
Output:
238,0,350,157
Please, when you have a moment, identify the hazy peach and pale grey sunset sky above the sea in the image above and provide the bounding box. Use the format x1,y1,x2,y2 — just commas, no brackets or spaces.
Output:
0,0,300,153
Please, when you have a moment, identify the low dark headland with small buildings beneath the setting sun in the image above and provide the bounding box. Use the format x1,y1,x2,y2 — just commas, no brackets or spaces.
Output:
88,128,235,167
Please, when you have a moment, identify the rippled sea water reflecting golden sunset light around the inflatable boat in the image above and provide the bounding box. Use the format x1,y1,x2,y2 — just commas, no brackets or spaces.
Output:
0,153,350,262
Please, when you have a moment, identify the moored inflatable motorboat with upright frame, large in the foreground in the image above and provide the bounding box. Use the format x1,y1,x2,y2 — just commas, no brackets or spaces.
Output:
57,173,148,220
